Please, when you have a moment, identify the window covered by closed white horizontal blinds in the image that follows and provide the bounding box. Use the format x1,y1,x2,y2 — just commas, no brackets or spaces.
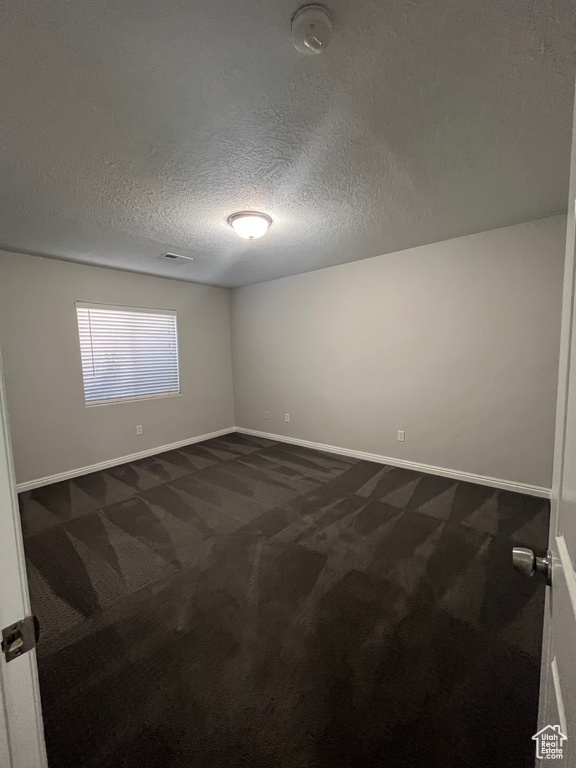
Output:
76,302,180,405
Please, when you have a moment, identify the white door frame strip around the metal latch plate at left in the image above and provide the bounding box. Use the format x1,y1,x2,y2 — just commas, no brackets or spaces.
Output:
0,344,47,768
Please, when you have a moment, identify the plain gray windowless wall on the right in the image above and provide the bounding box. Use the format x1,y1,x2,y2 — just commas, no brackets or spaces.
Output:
232,216,566,487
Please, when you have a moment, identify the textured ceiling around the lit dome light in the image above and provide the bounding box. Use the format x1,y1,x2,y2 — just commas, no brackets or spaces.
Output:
0,0,575,286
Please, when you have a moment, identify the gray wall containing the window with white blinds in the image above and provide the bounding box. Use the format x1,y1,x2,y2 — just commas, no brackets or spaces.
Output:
0,252,234,483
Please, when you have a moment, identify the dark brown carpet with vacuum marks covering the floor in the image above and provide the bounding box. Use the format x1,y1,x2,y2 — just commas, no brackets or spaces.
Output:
20,434,549,768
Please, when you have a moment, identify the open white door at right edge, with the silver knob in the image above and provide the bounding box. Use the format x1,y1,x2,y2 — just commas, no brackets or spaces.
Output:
535,79,576,768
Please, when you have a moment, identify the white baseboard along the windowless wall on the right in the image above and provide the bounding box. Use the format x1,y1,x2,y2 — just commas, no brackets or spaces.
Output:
236,427,551,499
